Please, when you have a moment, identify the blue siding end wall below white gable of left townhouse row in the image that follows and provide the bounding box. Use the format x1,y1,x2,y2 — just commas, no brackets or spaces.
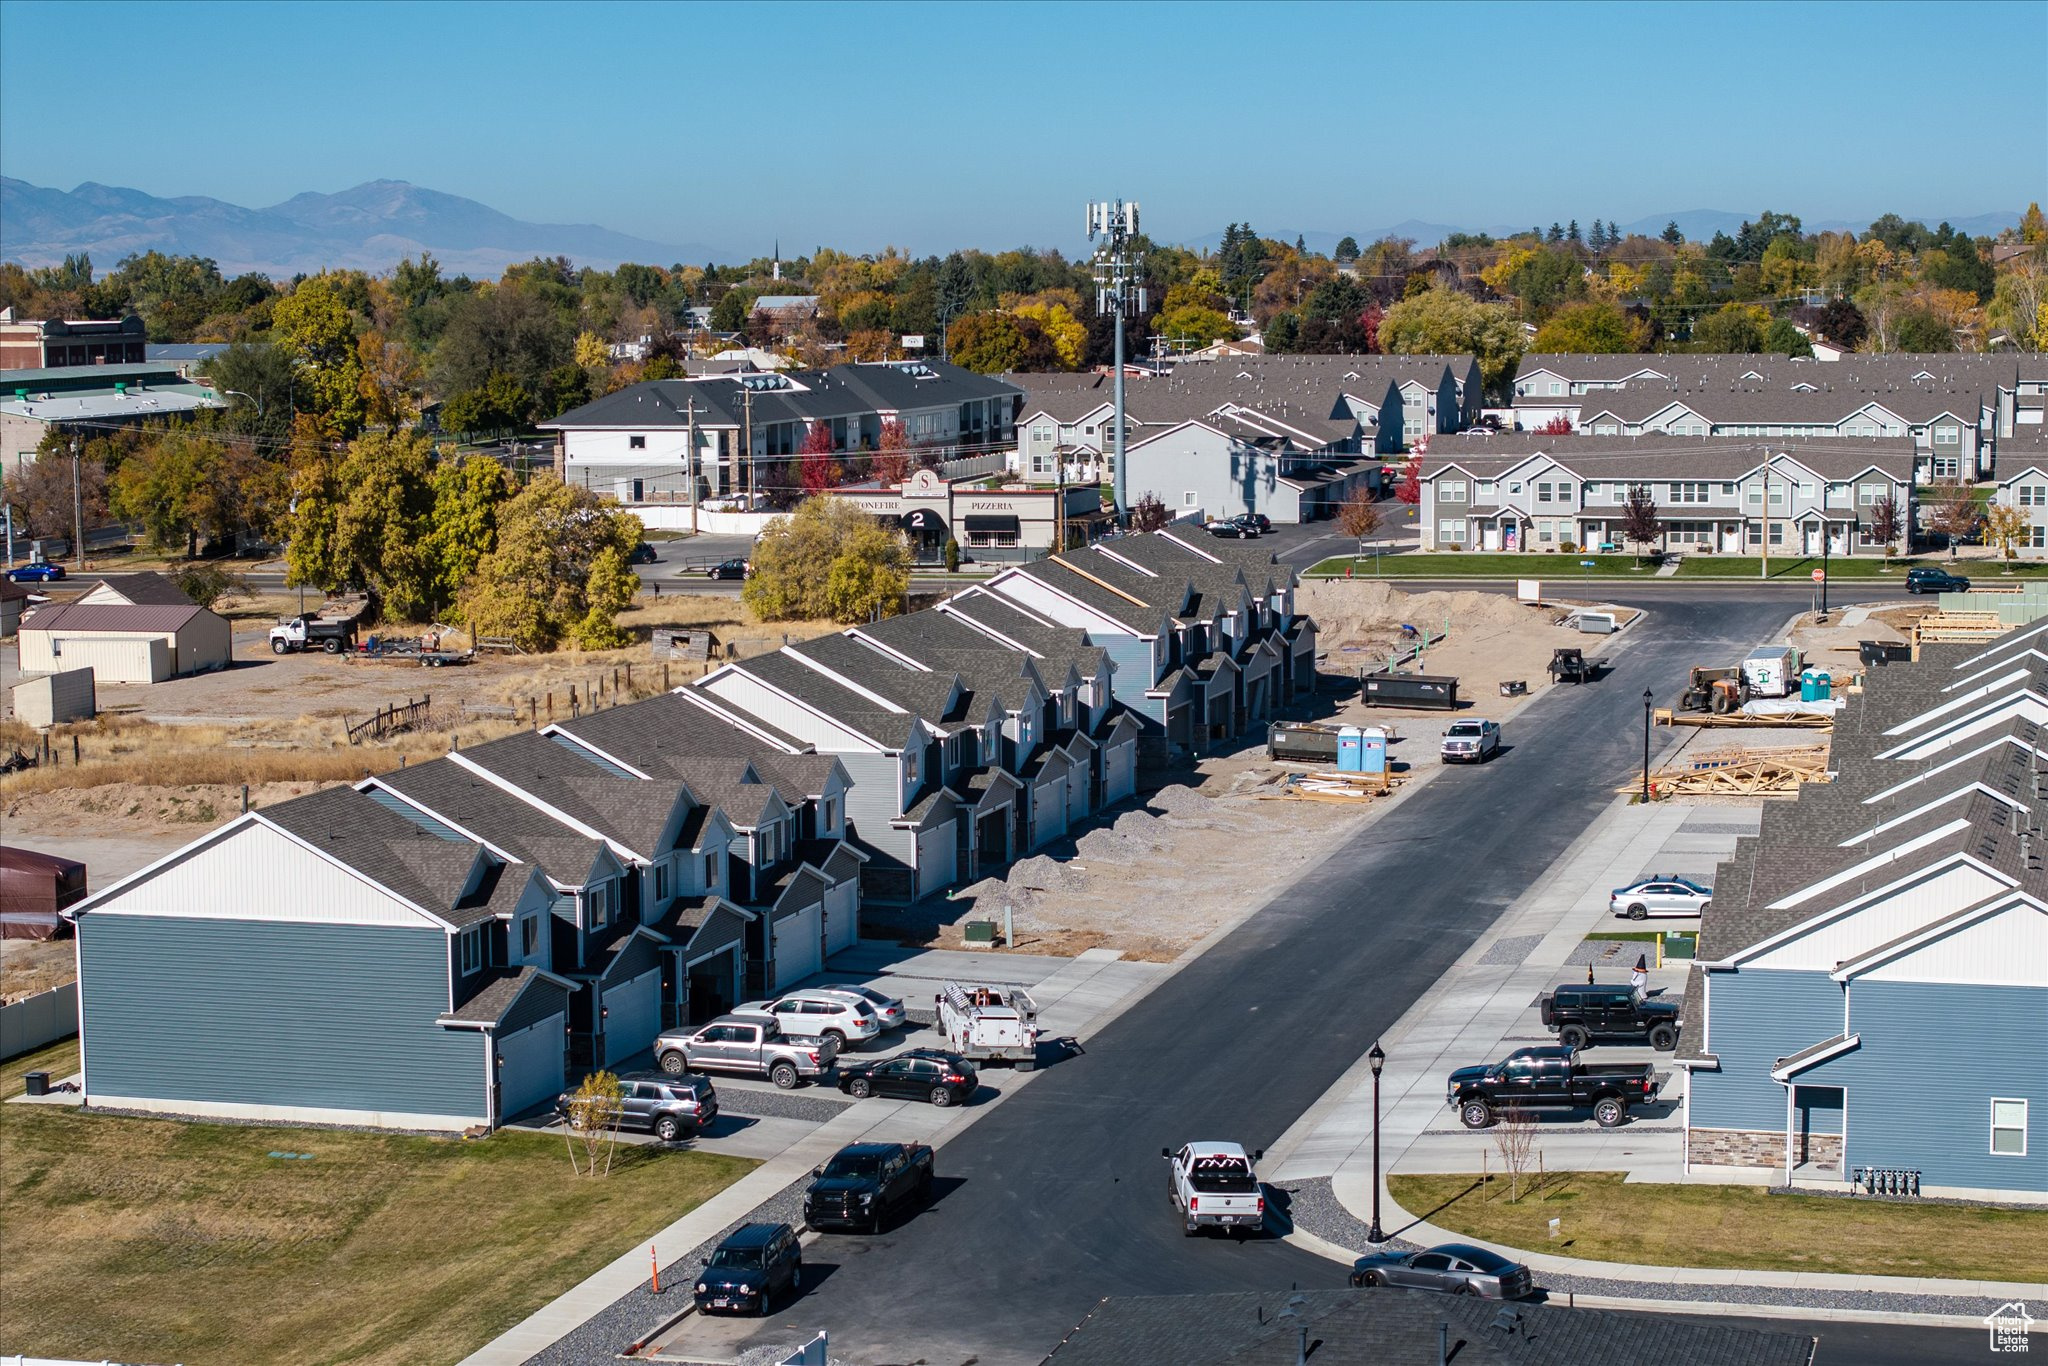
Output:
78,913,485,1118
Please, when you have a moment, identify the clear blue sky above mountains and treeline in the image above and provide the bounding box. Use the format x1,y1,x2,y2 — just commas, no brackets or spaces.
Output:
0,0,2048,252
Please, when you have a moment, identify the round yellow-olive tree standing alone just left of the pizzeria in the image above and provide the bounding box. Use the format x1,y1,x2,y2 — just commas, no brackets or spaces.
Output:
739,498,909,625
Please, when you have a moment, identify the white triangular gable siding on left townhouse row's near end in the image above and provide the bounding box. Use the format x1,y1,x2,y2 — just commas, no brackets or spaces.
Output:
88,821,438,926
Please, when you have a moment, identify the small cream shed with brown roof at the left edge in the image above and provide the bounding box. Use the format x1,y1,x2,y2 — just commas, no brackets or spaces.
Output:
20,602,231,686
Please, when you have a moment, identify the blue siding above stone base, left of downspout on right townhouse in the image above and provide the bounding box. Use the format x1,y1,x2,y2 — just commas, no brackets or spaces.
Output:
1692,969,1841,1133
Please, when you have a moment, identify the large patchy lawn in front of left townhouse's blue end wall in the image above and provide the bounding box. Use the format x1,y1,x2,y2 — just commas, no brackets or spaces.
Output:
0,1040,756,1366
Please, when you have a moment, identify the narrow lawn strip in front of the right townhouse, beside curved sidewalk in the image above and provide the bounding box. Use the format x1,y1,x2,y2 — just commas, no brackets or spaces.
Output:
1386,1171,2048,1280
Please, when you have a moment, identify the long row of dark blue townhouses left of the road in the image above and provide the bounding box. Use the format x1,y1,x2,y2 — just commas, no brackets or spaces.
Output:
68,535,1315,1130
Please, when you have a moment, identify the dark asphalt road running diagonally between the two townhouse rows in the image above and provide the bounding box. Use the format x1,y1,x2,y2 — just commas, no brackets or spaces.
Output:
688,590,1980,1366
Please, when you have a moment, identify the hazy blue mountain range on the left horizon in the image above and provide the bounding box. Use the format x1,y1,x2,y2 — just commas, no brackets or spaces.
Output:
0,176,729,279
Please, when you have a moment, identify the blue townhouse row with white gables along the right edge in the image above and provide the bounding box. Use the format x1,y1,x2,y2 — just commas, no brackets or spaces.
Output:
1675,625,2048,1200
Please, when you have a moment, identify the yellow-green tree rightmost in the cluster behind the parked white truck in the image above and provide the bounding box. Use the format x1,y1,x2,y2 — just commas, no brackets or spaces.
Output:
459,475,641,649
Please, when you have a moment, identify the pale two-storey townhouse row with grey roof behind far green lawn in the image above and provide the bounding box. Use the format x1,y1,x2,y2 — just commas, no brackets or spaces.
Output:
1417,444,1917,557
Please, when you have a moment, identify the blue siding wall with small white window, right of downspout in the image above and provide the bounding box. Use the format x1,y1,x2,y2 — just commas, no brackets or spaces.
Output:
1802,981,2048,1192
